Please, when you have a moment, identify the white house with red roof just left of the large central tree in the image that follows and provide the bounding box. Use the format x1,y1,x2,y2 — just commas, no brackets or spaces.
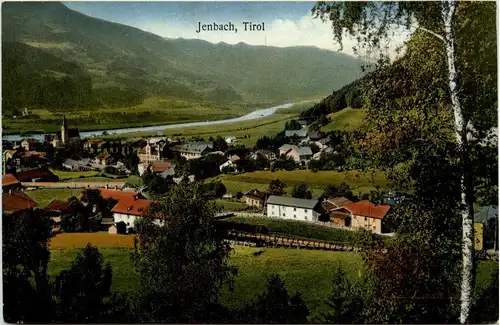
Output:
111,198,162,229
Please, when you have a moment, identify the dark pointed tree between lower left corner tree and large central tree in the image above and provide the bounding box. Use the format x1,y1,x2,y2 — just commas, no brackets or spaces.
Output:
56,244,112,323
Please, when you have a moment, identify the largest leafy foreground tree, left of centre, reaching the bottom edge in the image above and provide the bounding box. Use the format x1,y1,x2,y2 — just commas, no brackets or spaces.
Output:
134,183,235,323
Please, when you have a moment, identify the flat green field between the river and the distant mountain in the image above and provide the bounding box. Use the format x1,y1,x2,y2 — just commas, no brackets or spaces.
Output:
2,97,275,134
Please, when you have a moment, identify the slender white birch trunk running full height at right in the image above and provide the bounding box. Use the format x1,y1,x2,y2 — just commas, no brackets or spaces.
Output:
441,0,474,324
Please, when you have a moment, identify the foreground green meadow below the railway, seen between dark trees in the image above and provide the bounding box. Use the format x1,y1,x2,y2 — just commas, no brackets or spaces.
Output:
48,246,498,311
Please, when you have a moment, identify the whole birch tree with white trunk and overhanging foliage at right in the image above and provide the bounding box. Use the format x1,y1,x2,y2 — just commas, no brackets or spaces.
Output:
312,0,496,323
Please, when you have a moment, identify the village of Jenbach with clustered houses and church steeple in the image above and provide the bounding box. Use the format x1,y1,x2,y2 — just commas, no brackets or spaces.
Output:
2,114,414,240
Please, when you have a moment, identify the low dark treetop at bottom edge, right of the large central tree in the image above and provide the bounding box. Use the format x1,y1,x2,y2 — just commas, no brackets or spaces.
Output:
236,274,309,324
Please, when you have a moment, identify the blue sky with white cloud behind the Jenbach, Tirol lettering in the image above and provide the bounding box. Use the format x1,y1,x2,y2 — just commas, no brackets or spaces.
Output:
64,2,409,57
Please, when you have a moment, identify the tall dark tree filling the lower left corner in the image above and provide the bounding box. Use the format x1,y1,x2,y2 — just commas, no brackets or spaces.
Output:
2,209,54,323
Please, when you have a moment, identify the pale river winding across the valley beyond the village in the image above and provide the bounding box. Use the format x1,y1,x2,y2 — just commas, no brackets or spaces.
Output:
2,100,314,141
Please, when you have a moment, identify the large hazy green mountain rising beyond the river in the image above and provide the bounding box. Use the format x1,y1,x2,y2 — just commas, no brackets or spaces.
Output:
2,2,362,114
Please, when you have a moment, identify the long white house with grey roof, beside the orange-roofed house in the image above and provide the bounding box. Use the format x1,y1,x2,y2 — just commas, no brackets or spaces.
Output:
267,195,322,222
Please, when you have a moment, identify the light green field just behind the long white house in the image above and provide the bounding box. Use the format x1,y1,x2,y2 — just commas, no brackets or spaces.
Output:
215,170,389,198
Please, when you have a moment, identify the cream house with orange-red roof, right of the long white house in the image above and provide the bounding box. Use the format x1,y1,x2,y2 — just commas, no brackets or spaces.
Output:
329,200,391,234
